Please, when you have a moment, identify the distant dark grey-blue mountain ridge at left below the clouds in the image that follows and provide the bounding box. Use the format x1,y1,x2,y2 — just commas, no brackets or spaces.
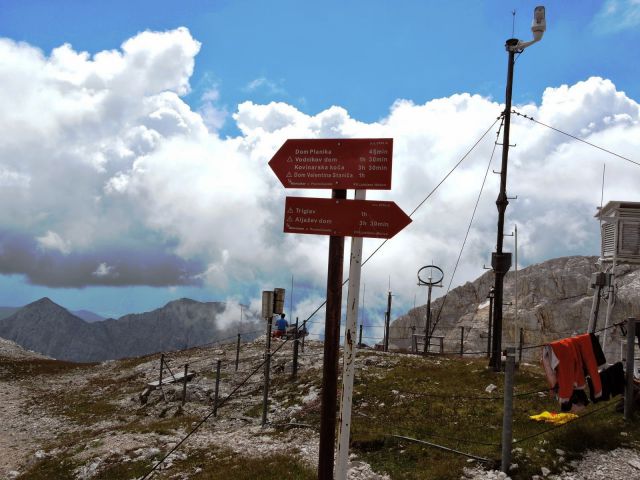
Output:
0,298,258,362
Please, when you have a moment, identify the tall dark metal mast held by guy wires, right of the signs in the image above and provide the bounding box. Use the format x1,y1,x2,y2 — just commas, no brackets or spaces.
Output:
491,38,518,372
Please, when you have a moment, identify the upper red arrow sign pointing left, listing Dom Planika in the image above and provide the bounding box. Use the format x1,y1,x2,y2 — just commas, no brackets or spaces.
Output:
269,138,393,190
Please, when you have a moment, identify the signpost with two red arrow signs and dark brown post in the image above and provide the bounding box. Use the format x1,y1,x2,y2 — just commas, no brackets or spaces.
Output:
269,138,411,480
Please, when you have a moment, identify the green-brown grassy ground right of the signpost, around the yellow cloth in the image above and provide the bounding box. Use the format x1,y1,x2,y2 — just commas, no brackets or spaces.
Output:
344,356,640,480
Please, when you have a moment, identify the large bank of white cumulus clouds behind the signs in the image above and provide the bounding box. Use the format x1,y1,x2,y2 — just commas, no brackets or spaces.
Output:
0,28,640,321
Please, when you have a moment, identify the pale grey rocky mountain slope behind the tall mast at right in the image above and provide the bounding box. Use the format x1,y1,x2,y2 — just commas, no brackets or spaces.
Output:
390,256,640,360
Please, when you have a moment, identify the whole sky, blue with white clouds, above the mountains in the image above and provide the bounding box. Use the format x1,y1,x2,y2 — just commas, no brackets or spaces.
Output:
0,0,640,336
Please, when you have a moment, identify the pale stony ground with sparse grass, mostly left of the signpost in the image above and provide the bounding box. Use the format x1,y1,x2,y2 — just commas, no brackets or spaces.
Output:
0,339,640,480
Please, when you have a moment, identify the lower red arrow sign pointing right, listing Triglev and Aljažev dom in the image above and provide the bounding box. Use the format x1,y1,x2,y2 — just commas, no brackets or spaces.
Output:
284,197,411,238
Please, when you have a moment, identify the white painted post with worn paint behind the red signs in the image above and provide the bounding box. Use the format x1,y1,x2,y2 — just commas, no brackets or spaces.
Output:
335,190,367,480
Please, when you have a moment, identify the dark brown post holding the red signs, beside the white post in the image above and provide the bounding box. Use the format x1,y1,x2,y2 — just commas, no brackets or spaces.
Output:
318,190,347,480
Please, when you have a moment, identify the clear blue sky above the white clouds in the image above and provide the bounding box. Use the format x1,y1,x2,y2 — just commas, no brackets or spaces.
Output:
0,0,640,131
